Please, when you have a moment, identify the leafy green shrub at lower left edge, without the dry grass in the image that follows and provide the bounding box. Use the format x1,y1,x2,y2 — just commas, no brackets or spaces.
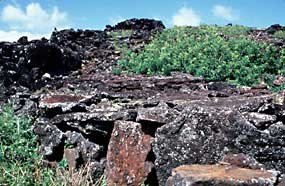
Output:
0,106,56,186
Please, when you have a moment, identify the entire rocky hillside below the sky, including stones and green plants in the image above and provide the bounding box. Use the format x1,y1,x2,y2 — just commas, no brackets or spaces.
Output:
0,19,285,186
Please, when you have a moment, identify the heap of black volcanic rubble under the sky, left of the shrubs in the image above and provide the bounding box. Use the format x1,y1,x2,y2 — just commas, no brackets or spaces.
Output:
0,19,165,104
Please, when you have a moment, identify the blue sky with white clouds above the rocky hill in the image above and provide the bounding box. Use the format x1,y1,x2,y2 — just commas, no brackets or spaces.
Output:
0,0,285,41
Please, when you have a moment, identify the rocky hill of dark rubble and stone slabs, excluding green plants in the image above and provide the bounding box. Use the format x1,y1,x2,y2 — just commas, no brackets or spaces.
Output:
0,19,285,186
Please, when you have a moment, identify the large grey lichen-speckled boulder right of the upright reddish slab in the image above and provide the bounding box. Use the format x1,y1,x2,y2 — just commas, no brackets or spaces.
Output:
153,94,285,185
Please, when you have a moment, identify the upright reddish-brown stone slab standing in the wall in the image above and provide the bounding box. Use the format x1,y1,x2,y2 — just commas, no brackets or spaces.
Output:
106,121,153,186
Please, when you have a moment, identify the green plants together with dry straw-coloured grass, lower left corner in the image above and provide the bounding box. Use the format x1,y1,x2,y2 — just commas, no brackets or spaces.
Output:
0,106,106,186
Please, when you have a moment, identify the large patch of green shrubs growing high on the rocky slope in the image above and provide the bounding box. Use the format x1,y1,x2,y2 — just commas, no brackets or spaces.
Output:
114,25,285,86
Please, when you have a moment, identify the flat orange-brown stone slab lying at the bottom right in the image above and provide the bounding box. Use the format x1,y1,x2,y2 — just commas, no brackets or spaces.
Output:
166,165,277,186
